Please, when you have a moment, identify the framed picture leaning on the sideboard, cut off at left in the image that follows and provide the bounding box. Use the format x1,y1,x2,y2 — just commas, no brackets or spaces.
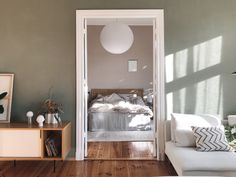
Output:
0,73,14,123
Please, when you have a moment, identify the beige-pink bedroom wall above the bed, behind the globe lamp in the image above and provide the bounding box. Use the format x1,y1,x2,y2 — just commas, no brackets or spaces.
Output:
88,26,153,89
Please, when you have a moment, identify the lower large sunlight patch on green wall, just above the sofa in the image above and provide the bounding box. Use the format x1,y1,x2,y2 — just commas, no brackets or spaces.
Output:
166,75,223,117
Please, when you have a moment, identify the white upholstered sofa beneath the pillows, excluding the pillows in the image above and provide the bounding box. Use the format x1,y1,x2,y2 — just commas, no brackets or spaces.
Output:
165,121,236,177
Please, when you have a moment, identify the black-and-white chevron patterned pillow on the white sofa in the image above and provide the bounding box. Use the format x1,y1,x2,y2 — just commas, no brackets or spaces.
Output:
192,127,233,151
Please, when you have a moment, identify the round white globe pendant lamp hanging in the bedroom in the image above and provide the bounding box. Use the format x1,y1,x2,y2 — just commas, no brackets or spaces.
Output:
100,22,134,54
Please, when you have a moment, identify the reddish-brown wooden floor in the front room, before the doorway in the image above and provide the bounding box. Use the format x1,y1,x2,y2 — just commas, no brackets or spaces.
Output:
0,160,173,177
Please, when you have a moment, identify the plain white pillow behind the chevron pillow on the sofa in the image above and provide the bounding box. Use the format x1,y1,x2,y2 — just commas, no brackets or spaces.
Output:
171,113,221,146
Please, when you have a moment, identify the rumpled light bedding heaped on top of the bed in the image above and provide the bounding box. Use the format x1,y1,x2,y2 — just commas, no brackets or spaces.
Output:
89,93,153,117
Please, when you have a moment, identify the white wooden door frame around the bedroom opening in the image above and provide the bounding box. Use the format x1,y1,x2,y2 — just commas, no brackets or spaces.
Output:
76,9,166,160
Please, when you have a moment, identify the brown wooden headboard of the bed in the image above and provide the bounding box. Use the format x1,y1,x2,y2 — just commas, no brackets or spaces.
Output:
89,89,143,100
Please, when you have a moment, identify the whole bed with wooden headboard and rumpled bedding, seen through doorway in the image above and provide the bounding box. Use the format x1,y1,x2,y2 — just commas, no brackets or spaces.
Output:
88,89,153,131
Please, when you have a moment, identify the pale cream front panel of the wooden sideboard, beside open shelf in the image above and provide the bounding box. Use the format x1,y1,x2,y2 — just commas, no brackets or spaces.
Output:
0,129,41,157
